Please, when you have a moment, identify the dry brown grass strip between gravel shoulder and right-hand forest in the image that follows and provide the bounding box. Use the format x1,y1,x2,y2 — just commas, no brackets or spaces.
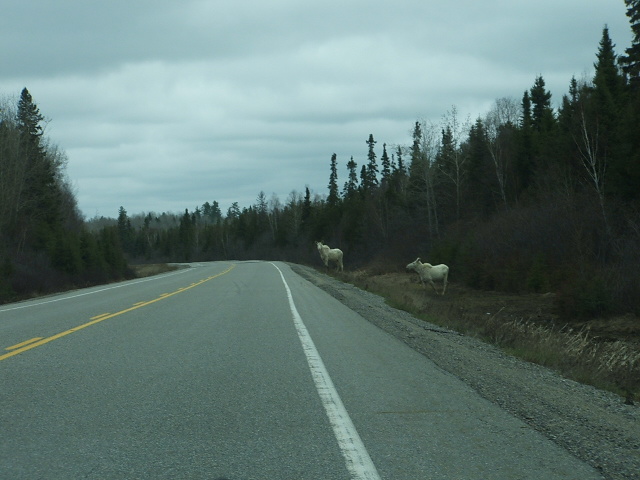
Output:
341,270,640,403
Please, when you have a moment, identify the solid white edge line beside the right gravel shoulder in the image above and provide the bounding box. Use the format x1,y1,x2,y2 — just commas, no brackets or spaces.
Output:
271,263,380,480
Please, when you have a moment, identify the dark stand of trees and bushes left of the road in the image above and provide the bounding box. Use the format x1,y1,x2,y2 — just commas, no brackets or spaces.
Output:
0,88,128,303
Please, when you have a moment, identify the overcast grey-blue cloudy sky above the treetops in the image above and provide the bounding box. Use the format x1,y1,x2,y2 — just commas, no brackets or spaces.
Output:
0,0,631,218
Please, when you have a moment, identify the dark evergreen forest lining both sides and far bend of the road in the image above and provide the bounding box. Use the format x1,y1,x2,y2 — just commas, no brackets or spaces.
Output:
0,4,640,316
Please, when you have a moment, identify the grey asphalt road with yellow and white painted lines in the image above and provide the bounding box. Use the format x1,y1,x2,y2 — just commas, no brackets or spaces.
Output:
0,262,601,480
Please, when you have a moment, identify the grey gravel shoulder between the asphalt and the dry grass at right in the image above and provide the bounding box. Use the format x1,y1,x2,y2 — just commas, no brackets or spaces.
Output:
289,264,640,480
